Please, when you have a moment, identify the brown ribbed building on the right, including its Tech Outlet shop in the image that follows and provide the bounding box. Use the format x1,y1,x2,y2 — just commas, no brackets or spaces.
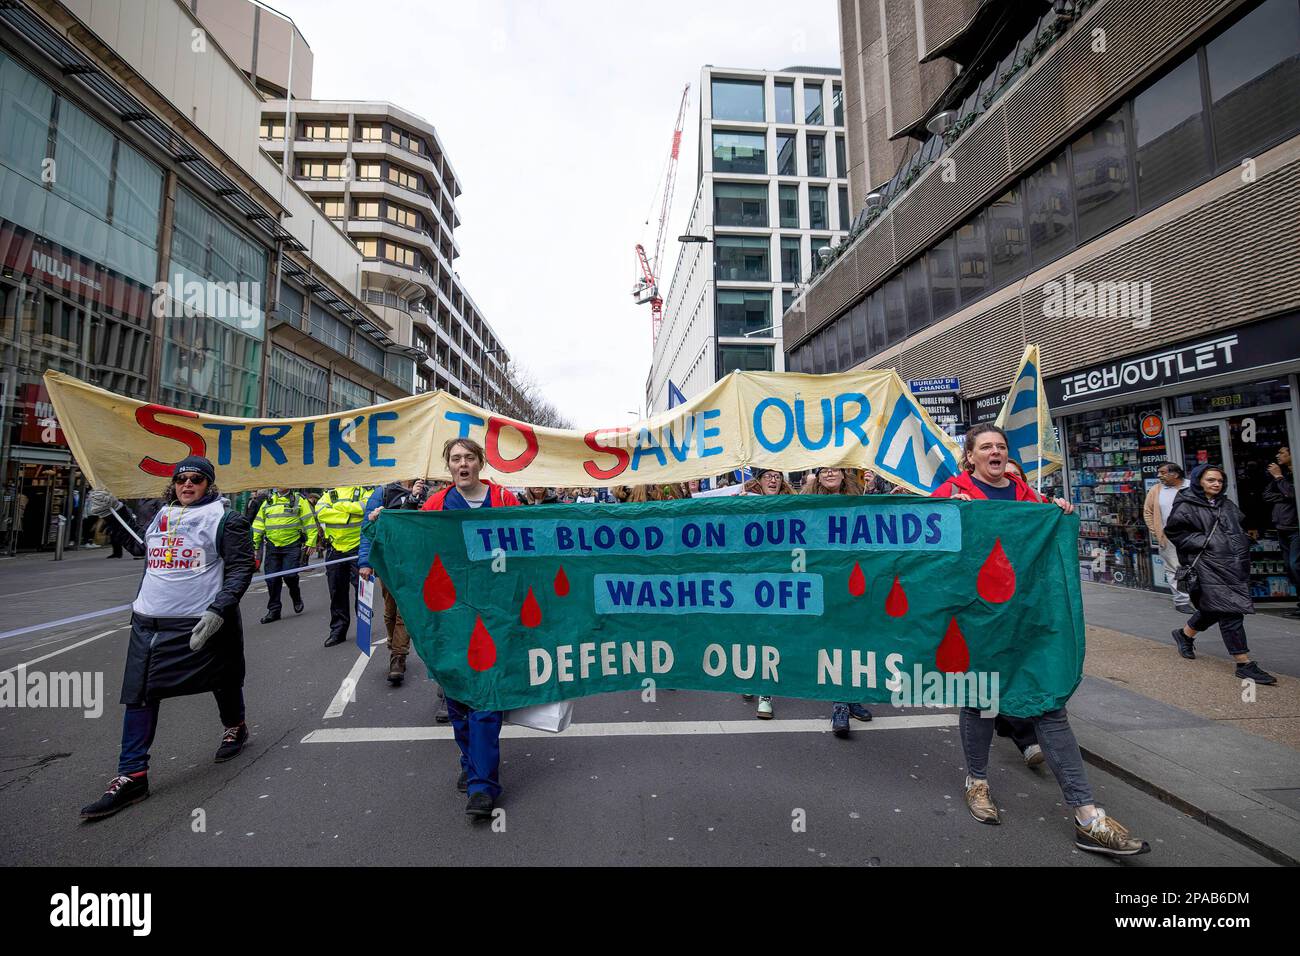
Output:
784,0,1300,602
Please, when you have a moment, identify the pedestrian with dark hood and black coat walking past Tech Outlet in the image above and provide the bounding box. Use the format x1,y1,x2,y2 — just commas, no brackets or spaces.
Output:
1165,464,1278,684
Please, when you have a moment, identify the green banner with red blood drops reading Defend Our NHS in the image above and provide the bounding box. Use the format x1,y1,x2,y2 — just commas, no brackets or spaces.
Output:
364,496,1084,717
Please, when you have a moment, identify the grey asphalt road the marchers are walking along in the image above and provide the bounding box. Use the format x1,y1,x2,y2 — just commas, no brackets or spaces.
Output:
0,551,1266,868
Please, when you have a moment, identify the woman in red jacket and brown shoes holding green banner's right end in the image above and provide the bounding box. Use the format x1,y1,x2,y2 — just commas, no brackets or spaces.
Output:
931,423,1151,856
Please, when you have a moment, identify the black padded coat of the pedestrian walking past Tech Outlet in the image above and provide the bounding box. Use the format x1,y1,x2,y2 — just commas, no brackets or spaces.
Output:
1165,488,1255,614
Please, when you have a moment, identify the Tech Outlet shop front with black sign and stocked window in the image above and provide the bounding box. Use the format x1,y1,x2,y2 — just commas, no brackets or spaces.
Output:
1045,313,1300,602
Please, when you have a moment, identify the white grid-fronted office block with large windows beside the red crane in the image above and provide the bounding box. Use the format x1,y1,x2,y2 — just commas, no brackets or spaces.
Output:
646,66,849,414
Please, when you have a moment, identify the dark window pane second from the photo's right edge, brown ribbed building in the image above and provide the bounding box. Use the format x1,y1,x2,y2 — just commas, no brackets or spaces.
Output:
1134,56,1209,209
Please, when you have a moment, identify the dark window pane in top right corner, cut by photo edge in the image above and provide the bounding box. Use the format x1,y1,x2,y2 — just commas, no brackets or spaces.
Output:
1205,0,1300,168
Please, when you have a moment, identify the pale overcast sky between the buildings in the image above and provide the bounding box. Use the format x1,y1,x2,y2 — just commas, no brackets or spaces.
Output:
277,0,840,427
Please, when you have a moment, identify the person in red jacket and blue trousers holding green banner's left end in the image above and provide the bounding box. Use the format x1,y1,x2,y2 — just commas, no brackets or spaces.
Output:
421,438,519,821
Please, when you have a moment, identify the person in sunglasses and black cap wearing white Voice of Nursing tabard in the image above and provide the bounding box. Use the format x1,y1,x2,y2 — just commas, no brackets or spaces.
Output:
81,455,254,819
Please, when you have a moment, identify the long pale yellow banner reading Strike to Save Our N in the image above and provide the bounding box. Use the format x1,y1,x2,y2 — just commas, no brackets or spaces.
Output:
46,369,958,498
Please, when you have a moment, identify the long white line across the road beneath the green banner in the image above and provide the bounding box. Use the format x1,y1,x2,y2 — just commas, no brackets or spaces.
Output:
299,710,957,744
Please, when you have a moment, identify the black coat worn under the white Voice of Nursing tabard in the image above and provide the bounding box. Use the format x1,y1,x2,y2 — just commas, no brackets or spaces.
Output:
114,496,254,705
